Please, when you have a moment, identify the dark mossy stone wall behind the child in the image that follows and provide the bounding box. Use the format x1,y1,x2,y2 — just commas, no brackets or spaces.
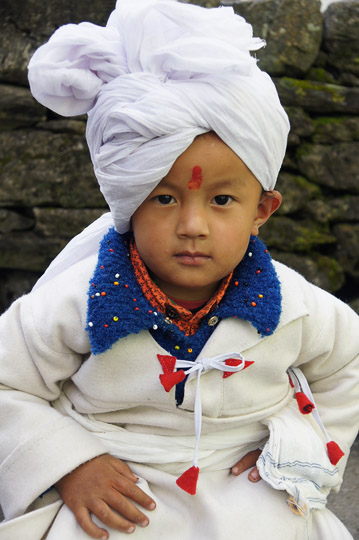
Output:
0,0,359,312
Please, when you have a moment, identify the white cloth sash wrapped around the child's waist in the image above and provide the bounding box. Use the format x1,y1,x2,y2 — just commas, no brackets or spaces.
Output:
56,395,268,476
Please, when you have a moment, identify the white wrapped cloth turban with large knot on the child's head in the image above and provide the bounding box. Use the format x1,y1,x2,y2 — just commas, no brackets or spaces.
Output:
29,0,289,233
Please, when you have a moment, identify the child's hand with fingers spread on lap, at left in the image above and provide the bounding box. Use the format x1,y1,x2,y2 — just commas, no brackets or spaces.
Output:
55,454,156,539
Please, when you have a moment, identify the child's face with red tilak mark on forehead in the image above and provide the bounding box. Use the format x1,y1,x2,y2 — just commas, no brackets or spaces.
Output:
132,133,281,300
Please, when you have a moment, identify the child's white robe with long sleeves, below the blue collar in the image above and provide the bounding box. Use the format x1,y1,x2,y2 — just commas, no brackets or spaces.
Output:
0,257,359,540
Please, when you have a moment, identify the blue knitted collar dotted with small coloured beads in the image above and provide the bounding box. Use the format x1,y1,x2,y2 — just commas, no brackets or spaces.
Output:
87,228,281,354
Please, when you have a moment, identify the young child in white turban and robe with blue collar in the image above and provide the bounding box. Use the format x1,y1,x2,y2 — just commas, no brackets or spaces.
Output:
0,0,359,540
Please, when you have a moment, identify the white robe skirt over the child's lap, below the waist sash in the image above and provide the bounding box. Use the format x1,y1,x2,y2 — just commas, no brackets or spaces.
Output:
0,466,318,540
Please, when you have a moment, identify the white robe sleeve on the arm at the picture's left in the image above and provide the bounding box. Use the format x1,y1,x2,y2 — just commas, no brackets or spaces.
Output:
0,259,105,519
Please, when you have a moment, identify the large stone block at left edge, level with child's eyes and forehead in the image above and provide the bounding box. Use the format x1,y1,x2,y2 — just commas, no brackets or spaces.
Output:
0,130,107,208
